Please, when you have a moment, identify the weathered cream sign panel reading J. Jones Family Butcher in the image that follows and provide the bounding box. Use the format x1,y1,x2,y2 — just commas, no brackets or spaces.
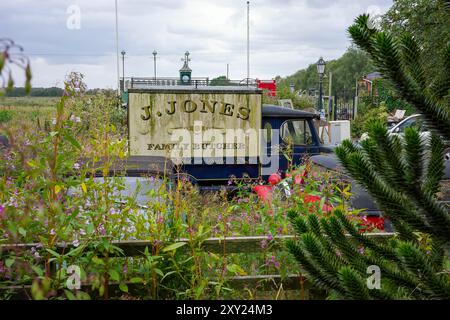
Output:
128,87,262,161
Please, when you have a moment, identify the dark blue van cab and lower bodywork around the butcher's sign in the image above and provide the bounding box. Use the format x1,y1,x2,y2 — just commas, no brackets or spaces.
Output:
181,105,332,186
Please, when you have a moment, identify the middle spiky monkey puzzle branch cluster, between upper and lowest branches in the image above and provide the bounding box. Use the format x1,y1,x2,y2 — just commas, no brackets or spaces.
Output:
336,123,450,241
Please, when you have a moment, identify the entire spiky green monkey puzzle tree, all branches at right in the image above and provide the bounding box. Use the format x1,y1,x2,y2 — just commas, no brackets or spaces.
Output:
287,11,450,299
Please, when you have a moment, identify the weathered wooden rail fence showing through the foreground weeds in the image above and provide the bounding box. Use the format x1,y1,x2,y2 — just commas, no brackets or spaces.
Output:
0,233,394,299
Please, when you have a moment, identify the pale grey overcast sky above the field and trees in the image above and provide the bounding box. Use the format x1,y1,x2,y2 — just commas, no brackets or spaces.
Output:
0,0,392,88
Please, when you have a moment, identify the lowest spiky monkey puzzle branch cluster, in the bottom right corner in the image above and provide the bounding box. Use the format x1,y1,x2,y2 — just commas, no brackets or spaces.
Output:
287,210,450,299
